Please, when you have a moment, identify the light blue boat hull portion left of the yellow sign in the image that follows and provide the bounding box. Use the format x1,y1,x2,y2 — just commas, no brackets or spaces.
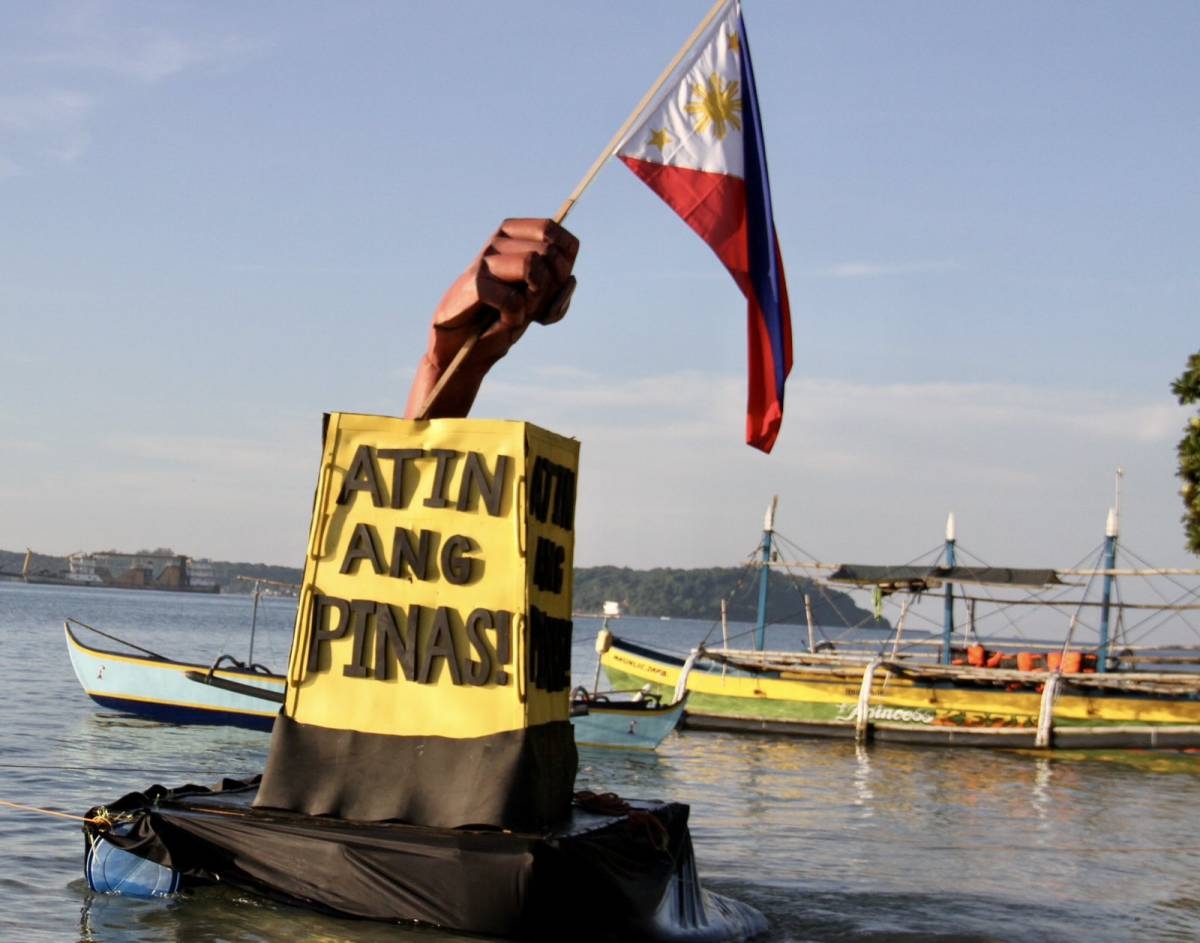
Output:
65,625,286,731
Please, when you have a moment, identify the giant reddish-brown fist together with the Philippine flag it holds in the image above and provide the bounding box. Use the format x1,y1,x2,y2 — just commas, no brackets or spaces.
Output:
407,0,792,452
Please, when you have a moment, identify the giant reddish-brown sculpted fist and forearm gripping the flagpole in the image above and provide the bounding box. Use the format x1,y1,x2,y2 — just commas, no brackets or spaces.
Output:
404,218,580,419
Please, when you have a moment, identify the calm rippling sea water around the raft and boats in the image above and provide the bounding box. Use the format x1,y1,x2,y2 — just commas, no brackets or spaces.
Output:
0,582,1200,943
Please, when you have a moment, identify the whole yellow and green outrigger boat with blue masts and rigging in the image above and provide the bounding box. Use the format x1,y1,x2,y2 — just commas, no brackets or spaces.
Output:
601,504,1200,749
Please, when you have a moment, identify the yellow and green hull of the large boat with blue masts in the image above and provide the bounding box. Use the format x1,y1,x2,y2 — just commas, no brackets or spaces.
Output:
601,638,1200,747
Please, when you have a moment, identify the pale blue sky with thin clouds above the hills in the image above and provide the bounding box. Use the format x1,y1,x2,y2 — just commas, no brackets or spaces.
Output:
0,0,1200,567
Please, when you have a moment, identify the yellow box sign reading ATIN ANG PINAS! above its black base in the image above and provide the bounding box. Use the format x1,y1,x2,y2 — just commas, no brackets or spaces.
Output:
284,413,578,738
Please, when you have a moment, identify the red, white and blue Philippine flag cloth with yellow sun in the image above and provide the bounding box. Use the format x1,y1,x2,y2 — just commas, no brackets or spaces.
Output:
617,4,792,452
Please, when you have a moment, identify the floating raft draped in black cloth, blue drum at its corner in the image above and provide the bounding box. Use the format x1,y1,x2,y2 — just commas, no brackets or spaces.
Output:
85,777,767,943
